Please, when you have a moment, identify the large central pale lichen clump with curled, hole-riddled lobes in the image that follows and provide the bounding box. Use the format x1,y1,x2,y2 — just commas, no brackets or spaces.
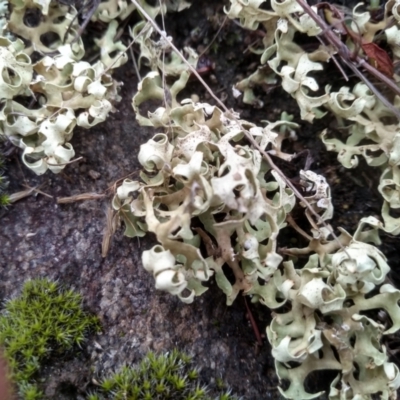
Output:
113,102,294,304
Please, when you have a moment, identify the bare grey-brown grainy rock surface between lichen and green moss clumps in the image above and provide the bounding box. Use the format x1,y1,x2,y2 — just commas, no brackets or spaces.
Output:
0,56,277,400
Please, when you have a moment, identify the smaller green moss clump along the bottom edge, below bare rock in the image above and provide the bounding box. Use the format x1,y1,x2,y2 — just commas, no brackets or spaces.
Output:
87,350,237,400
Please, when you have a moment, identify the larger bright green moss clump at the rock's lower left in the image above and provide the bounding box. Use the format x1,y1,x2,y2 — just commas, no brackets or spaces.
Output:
0,279,98,400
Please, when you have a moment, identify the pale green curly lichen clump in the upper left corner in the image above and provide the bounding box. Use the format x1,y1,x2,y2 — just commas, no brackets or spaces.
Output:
0,1,127,174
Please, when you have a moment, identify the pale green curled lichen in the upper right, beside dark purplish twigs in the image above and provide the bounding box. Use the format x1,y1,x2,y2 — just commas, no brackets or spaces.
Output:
226,0,400,235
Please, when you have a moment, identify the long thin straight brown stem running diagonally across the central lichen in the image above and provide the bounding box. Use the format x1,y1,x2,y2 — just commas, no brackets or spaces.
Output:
132,0,351,259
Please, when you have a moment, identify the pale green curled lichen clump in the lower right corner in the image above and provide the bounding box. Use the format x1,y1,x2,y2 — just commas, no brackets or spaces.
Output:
267,218,400,399
